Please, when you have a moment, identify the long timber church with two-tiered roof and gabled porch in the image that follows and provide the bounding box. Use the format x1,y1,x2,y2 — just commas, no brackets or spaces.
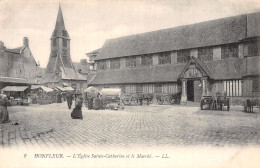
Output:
89,12,260,105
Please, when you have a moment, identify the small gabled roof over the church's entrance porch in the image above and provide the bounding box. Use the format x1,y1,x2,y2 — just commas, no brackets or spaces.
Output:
179,57,213,78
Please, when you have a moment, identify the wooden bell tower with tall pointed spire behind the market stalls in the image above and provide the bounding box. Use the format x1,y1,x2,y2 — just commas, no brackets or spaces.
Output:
43,6,87,90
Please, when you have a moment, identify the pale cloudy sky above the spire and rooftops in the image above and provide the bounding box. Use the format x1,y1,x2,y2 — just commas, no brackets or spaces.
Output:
0,0,260,68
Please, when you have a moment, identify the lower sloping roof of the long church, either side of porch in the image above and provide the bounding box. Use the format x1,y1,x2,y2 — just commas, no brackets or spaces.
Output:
89,58,248,85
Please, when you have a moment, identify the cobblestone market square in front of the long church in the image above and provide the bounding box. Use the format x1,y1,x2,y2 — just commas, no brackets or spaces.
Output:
0,103,260,148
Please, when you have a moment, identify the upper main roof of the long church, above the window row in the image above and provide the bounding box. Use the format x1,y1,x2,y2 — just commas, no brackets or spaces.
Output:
95,12,260,60
